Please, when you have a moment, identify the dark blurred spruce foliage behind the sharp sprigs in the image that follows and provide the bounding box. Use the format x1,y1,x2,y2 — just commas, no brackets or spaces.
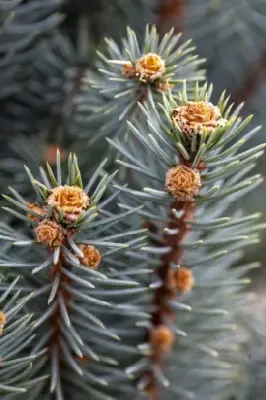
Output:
0,0,266,284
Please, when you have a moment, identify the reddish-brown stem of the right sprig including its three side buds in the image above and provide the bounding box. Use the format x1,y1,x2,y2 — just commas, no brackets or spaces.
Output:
146,146,207,400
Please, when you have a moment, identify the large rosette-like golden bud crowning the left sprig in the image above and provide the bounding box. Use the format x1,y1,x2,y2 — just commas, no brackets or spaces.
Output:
47,185,89,222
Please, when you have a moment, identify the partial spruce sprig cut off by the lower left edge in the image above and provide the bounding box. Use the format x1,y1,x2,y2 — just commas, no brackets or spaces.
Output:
0,277,48,400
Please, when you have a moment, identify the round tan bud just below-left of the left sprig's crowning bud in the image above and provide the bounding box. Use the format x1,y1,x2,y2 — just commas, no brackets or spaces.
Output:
34,219,64,247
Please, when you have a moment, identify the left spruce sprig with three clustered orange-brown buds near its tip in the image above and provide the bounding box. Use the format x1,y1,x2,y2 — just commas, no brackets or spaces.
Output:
0,152,149,399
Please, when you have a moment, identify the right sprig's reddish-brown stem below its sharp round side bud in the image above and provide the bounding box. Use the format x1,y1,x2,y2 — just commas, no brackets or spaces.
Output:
147,201,196,400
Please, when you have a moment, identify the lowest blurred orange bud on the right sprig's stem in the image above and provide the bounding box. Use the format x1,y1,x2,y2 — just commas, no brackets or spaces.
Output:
150,325,175,354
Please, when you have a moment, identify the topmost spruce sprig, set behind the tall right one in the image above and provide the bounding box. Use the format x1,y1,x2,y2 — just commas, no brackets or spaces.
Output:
77,26,205,144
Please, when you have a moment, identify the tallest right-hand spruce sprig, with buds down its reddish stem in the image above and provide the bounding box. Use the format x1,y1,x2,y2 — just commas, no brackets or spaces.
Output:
109,85,265,399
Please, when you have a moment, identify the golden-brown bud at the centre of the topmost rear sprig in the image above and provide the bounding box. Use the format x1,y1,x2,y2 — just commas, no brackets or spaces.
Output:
135,53,165,82
